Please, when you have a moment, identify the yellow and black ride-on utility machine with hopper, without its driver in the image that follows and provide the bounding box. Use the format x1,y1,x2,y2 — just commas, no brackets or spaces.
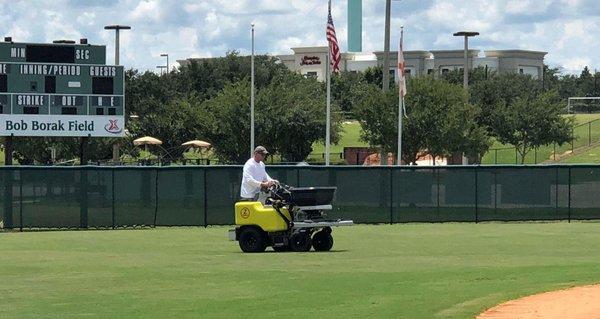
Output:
229,184,354,253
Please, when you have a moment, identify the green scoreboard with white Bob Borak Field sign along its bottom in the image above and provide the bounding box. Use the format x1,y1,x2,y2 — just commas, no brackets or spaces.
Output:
0,42,125,137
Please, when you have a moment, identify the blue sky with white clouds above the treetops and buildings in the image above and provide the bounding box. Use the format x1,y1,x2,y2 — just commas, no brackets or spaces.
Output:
0,0,600,73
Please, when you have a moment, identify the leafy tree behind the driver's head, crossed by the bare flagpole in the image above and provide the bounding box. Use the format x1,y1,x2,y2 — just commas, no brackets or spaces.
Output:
203,72,340,163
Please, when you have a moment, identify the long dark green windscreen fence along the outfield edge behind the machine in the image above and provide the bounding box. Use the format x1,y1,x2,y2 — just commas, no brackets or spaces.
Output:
0,165,600,229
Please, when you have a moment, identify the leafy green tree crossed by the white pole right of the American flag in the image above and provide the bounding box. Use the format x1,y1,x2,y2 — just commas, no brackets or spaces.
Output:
356,77,490,163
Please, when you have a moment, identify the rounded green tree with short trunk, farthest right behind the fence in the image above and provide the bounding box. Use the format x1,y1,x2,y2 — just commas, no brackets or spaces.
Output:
496,91,573,164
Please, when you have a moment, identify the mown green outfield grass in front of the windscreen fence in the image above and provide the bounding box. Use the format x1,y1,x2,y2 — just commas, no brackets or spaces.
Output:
0,222,600,318
